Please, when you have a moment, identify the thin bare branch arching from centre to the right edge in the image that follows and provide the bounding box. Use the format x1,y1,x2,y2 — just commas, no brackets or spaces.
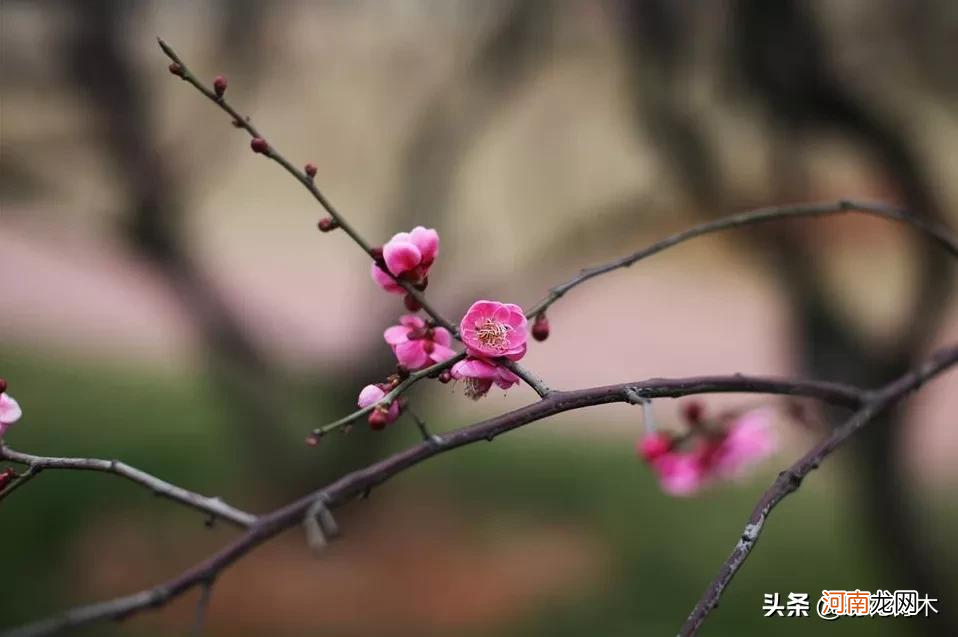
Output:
526,200,958,318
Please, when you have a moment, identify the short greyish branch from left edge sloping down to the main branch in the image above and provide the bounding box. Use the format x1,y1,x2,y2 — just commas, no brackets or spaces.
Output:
0,444,257,528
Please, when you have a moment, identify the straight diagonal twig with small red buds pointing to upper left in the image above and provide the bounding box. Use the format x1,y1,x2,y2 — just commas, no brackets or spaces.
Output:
156,38,457,334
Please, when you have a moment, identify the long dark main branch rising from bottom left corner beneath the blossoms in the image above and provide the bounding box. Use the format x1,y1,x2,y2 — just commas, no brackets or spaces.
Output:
2,360,916,637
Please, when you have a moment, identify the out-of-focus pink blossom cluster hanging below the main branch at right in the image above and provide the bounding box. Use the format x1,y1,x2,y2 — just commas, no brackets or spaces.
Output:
637,402,777,496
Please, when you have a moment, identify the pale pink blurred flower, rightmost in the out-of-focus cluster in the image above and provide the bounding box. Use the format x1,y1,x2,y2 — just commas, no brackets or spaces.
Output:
710,408,778,479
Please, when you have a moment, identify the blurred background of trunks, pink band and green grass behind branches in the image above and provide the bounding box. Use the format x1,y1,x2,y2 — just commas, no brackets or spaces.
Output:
0,0,958,637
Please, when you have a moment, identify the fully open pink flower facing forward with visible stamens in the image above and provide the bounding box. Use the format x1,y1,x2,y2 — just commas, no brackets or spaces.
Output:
459,301,527,361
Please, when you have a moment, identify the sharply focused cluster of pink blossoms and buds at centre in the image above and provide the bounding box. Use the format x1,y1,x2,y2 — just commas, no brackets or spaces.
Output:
357,226,536,429
